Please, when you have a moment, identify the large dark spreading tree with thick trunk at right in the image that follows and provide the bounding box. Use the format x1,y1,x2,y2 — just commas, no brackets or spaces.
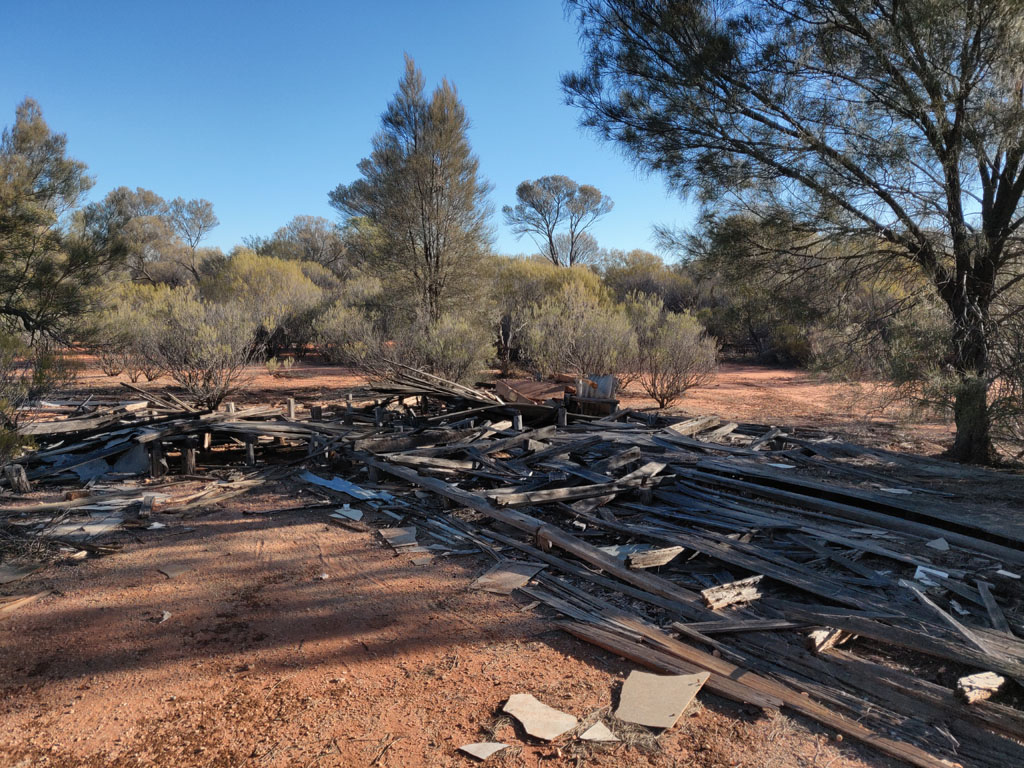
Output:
563,0,1024,462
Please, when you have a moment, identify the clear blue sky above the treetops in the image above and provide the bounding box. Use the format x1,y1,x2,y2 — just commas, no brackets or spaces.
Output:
0,0,692,259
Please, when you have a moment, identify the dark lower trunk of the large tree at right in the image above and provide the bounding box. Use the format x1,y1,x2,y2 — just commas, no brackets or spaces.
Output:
949,312,993,464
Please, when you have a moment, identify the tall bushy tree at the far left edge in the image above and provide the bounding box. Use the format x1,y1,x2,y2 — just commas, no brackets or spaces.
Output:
0,99,124,341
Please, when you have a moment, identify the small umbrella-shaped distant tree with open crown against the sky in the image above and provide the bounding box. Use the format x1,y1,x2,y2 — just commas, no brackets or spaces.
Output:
502,176,614,266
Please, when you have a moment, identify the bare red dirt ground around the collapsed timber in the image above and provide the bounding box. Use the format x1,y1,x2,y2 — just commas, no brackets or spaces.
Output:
0,366,942,768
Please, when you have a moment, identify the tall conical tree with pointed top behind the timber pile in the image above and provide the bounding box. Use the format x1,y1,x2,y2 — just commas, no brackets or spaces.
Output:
329,55,490,322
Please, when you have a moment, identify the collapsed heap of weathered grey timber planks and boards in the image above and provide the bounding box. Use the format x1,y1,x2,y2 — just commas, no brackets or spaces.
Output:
0,372,1024,768
